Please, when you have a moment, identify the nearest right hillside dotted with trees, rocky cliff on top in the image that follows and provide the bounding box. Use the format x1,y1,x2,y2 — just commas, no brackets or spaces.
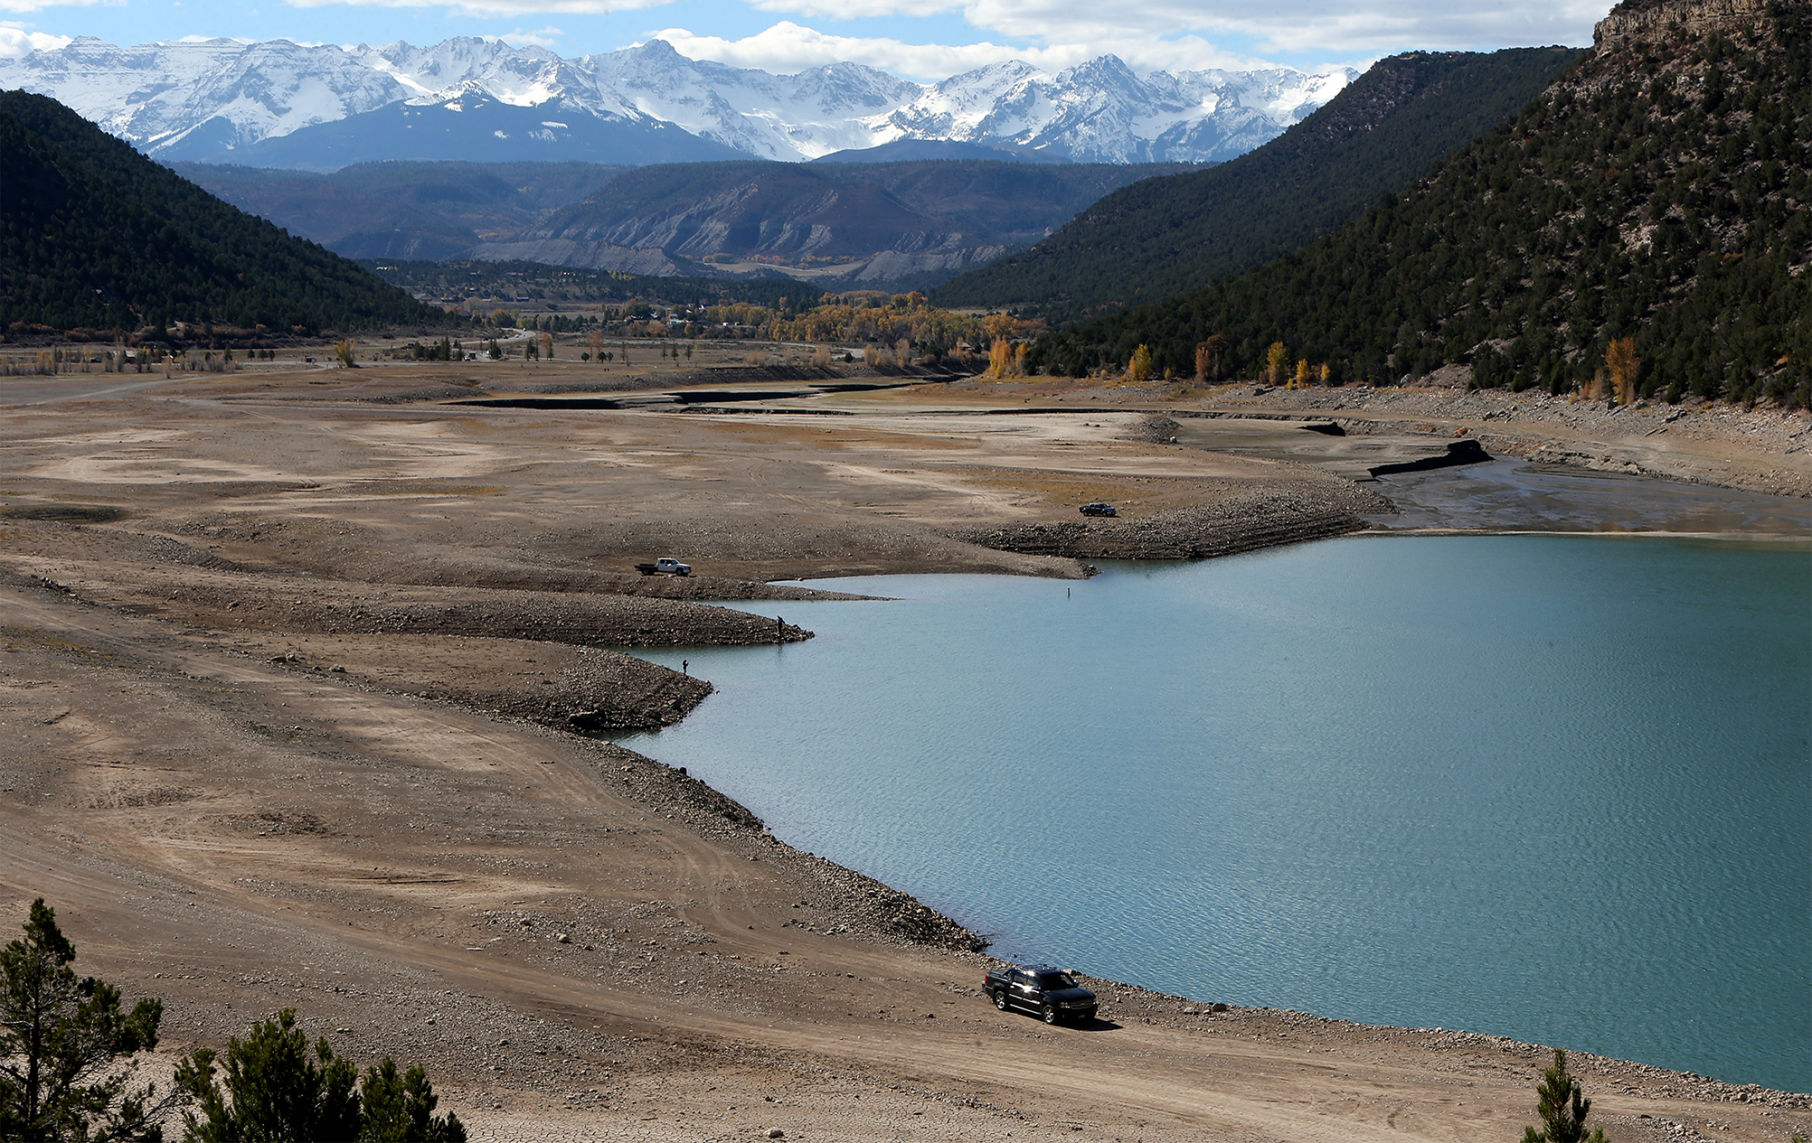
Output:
1027,0,1812,406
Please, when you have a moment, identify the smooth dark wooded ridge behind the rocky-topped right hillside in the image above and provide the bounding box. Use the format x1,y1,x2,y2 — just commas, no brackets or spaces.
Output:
935,47,1580,321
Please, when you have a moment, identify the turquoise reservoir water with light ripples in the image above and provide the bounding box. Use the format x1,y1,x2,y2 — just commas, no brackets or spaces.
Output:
623,536,1812,1090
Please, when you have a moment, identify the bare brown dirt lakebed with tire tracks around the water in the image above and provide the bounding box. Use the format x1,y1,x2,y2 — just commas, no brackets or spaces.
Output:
0,370,1812,1143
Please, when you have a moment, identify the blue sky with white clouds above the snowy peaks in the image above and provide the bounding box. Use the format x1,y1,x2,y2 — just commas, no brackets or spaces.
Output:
0,0,1611,80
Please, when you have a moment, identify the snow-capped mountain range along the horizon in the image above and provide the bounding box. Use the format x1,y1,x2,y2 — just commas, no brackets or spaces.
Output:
0,38,1355,168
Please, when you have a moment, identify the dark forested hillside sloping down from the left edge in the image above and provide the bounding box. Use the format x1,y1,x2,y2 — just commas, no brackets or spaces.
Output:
0,91,444,335
